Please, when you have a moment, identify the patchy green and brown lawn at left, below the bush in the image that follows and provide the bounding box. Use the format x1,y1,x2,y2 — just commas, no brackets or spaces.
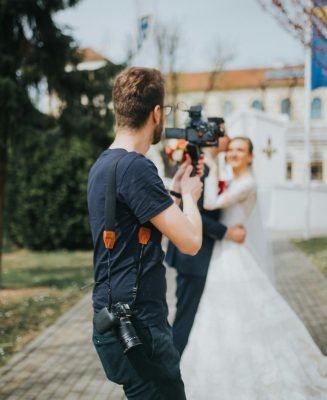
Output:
0,250,92,365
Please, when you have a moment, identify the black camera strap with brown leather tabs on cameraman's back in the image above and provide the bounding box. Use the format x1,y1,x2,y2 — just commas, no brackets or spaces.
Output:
103,154,151,310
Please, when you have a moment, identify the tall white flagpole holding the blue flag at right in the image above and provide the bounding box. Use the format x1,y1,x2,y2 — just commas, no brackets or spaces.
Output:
304,8,312,239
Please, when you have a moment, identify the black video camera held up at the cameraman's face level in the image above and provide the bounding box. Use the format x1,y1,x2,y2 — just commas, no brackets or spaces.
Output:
165,106,225,167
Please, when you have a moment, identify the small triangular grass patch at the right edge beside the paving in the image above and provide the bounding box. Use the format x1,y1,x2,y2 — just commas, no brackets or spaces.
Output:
293,237,327,278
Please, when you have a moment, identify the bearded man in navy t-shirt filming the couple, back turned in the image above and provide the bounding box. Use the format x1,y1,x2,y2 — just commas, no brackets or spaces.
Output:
88,67,203,400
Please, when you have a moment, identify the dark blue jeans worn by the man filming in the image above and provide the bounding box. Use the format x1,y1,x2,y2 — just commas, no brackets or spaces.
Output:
93,323,186,400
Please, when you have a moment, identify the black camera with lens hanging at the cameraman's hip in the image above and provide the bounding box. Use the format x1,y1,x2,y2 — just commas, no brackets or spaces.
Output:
94,302,142,353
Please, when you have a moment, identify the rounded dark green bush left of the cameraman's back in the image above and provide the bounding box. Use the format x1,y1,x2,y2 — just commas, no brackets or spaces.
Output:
5,132,100,250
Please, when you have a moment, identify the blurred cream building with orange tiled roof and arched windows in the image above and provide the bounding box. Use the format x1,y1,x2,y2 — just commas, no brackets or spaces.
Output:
168,65,327,184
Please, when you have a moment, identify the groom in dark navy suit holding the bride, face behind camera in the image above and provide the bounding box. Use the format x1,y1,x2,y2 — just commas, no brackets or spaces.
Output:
166,134,245,355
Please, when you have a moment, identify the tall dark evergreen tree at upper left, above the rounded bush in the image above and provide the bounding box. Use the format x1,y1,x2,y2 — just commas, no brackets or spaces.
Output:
0,0,118,282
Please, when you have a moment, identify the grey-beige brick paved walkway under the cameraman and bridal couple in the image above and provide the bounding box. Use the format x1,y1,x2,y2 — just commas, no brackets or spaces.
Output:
0,241,327,400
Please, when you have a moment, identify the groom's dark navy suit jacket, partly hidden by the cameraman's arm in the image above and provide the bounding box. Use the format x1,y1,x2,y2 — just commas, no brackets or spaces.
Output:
166,167,227,277
